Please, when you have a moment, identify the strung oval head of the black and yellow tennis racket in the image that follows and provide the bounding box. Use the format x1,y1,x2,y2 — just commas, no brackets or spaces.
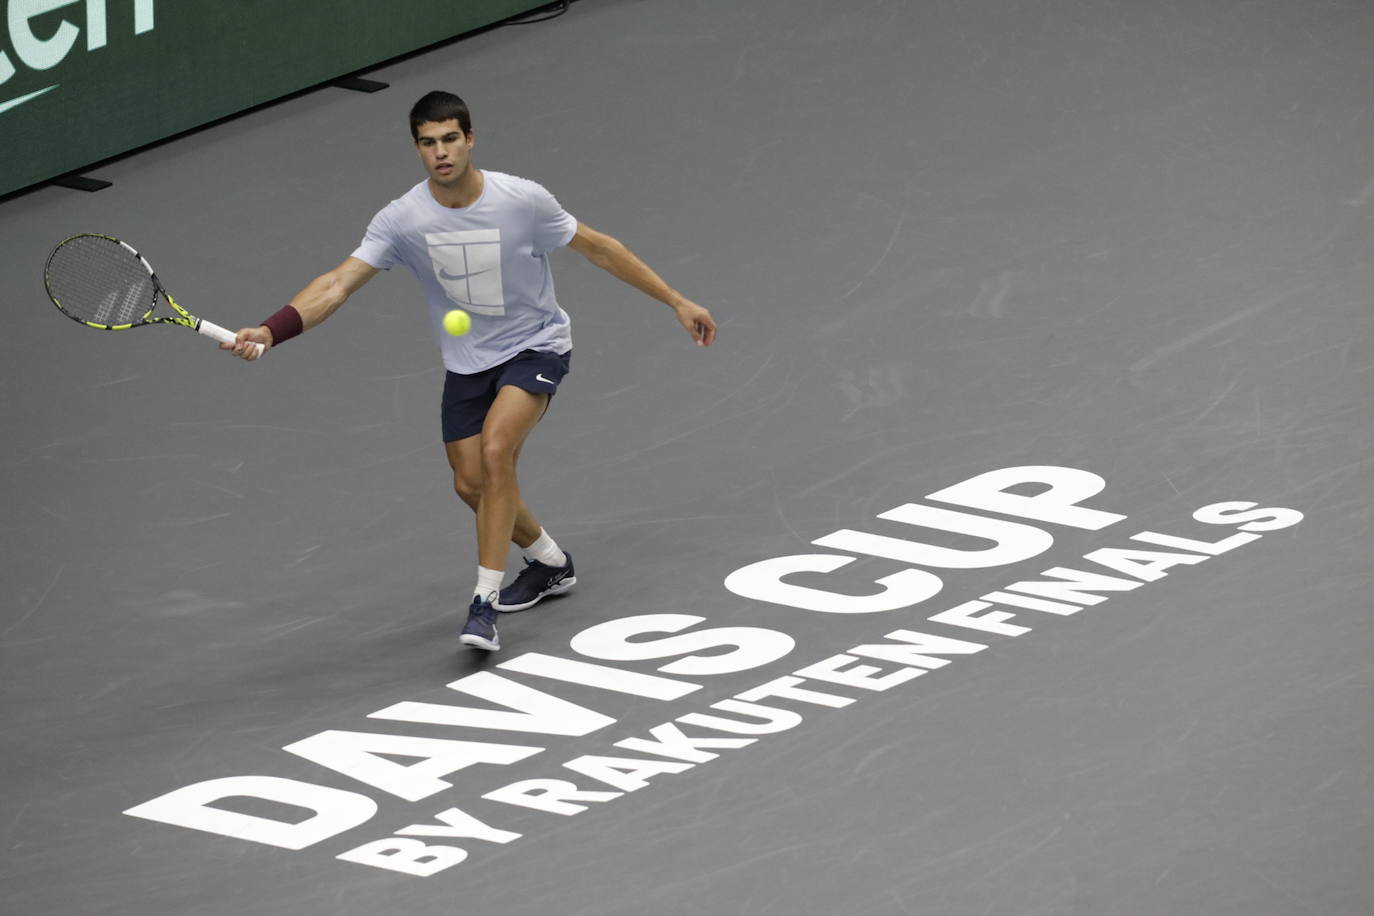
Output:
47,236,158,327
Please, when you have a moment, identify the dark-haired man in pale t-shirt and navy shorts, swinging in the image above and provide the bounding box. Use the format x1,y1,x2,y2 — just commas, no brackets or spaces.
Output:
221,92,716,651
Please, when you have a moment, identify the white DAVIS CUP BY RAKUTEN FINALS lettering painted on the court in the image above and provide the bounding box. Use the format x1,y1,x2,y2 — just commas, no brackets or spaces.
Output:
125,466,1303,878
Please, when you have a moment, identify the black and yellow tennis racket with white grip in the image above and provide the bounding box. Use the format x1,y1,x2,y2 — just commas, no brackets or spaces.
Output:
43,233,262,356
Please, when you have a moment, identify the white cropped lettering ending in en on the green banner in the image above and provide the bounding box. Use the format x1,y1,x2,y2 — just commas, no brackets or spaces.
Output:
0,0,154,114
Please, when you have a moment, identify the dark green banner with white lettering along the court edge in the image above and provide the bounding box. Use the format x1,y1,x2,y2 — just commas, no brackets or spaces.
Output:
0,0,547,195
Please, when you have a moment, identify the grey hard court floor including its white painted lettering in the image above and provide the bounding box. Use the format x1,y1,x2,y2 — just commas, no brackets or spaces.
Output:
0,0,1374,916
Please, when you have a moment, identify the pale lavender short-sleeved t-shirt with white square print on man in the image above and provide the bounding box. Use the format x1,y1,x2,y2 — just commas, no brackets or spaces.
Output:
353,169,577,375
